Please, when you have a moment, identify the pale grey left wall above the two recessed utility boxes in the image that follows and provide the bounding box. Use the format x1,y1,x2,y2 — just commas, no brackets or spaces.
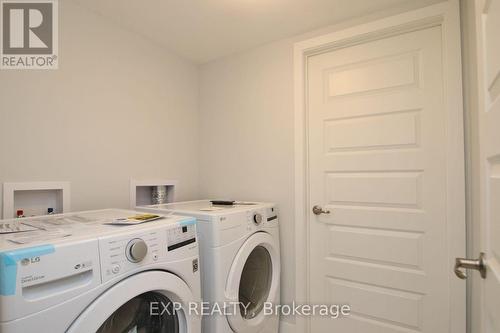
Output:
0,1,199,210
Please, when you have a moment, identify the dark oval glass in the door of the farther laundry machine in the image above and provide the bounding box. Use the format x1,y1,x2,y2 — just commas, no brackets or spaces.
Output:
238,245,273,319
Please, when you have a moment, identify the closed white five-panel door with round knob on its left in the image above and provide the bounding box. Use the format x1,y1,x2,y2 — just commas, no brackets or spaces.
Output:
307,26,466,333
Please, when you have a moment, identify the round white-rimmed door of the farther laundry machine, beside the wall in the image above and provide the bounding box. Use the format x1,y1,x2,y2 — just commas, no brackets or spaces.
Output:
226,232,280,332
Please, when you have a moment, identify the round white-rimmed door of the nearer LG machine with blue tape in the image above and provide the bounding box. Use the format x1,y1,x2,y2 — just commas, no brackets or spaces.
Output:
67,271,201,333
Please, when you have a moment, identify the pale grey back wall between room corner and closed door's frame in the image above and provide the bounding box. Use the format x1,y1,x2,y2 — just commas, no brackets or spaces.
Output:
200,1,444,322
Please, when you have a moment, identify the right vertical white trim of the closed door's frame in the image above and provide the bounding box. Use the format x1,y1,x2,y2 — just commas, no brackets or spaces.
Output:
442,0,467,333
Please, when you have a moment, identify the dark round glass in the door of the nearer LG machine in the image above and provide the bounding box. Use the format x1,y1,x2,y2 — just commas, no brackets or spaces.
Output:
96,291,179,333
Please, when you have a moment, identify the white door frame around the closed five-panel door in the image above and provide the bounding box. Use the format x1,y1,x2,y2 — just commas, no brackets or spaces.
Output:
294,0,467,333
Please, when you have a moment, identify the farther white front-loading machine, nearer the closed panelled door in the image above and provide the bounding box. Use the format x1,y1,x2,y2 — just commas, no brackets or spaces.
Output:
137,200,280,333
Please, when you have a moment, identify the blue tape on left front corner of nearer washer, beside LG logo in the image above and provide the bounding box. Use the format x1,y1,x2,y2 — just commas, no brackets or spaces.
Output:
0,245,55,296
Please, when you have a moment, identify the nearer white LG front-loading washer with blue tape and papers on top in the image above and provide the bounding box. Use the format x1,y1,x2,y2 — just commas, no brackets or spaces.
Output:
0,210,201,333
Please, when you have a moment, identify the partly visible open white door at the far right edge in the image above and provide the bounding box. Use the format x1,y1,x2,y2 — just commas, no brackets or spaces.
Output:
471,0,500,333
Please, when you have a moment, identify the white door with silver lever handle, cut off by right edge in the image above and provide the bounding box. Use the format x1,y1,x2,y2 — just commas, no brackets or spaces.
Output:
464,0,500,332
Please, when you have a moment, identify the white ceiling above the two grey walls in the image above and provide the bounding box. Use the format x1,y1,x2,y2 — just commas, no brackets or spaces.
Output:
71,0,438,63
